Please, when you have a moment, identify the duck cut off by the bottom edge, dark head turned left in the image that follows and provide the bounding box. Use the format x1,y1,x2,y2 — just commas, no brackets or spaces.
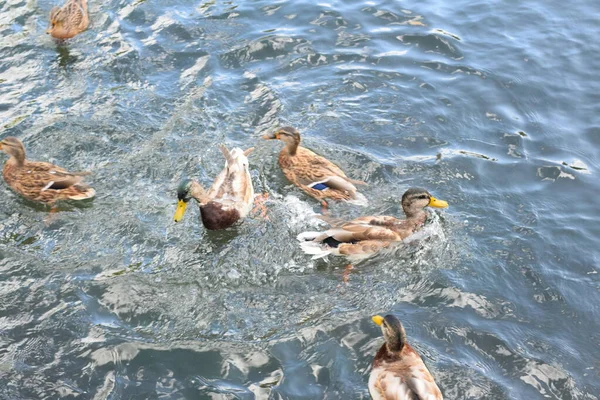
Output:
369,315,443,400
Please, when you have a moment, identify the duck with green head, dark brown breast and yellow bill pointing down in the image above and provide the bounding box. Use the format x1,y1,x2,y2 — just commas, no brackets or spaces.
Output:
174,146,254,230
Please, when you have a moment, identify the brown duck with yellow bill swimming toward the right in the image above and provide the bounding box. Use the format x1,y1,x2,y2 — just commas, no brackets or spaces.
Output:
298,188,448,259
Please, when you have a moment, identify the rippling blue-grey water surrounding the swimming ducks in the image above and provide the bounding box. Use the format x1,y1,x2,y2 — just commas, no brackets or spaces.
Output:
0,0,600,399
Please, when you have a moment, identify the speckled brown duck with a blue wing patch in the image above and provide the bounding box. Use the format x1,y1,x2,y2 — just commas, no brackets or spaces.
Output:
263,126,367,206
